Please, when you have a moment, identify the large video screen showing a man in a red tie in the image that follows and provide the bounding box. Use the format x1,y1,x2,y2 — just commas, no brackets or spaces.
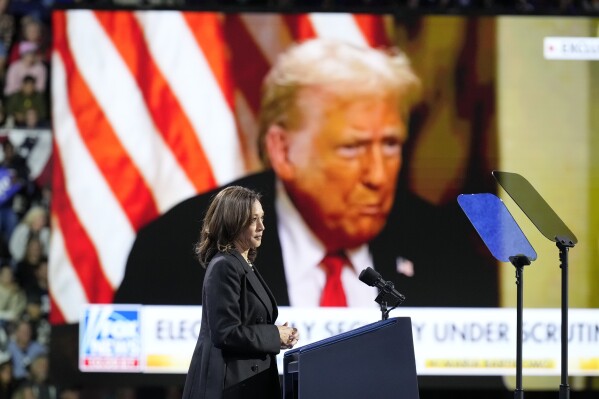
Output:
49,10,599,390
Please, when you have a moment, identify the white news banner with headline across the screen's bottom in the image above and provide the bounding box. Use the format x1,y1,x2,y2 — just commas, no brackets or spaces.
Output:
79,305,599,376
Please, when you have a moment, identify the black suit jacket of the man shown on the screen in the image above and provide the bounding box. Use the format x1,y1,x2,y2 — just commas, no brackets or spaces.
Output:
115,171,498,307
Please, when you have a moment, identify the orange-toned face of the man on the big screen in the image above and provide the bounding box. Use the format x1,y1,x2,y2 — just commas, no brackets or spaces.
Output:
282,88,406,249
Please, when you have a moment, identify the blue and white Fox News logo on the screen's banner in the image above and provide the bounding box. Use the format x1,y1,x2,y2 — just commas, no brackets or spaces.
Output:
79,305,141,371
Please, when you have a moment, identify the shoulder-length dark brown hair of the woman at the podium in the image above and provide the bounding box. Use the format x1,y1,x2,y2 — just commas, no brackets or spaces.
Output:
196,186,260,267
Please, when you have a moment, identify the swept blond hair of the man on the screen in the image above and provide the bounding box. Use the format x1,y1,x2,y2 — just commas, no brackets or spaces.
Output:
258,39,420,166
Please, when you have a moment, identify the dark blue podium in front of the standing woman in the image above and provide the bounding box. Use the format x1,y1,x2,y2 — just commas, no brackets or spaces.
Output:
283,317,419,399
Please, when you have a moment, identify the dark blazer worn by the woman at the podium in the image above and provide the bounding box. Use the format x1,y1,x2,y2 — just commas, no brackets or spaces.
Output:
183,251,280,399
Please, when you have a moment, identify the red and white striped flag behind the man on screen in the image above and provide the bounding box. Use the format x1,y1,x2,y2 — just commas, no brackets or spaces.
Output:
49,10,390,324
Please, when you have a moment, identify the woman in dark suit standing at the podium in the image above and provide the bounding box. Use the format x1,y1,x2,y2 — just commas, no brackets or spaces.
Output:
183,186,299,399
